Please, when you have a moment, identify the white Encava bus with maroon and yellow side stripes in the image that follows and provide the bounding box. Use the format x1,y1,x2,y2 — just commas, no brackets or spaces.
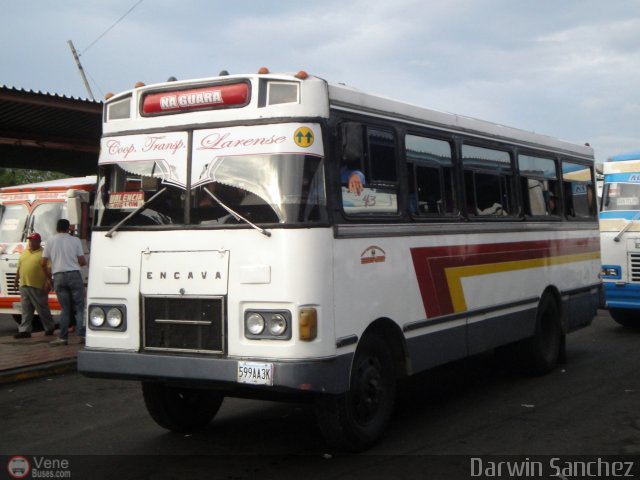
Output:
78,68,600,451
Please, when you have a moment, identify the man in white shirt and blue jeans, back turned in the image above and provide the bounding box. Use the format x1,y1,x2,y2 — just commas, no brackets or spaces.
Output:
41,218,87,346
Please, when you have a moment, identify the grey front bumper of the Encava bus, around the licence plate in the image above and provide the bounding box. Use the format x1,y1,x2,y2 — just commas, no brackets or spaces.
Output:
78,348,353,396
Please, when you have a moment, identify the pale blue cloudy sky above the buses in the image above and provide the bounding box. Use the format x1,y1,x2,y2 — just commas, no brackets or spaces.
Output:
0,0,640,161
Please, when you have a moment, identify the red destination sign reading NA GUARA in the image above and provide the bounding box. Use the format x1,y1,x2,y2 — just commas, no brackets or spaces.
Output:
142,83,249,114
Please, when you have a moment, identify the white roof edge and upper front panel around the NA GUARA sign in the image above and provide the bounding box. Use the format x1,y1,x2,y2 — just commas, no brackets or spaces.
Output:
103,73,593,161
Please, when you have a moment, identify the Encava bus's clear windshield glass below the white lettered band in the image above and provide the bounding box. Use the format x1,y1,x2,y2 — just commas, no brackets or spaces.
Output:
95,154,326,227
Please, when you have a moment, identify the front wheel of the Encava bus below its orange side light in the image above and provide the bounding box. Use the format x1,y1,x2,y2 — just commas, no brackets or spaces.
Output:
316,336,396,452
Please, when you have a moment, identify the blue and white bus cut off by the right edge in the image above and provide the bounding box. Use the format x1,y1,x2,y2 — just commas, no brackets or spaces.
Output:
600,152,640,327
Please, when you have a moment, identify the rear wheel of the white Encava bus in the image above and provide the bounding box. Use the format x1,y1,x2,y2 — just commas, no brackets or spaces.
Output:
516,295,565,375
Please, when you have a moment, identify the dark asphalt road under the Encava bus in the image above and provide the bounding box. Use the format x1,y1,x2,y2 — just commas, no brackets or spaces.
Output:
0,312,640,479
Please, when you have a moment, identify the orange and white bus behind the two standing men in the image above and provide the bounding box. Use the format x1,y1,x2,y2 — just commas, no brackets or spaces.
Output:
0,175,96,323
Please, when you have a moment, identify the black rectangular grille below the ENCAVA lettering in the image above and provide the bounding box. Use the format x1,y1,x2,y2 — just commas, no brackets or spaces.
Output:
142,297,224,353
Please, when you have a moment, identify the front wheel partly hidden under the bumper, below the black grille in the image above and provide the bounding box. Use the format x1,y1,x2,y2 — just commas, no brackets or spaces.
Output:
142,382,224,433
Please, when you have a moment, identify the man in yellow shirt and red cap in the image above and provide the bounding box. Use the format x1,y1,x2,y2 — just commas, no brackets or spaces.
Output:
13,232,55,338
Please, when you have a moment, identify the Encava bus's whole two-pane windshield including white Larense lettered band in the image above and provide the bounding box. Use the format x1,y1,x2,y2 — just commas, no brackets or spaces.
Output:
95,123,326,229
